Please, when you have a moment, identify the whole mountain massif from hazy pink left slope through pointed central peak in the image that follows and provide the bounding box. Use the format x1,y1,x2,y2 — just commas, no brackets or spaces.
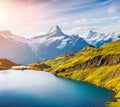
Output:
0,26,88,64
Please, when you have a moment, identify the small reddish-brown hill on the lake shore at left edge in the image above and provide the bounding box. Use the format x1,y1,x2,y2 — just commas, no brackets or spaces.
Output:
0,58,20,70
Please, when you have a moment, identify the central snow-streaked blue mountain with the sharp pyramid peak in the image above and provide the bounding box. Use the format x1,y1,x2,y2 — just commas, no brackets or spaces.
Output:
28,26,88,61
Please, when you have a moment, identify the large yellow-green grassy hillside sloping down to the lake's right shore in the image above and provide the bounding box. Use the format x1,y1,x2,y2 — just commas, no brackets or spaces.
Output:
31,40,120,107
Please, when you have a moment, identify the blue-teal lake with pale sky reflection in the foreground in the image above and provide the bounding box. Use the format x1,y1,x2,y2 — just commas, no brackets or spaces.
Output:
0,70,113,107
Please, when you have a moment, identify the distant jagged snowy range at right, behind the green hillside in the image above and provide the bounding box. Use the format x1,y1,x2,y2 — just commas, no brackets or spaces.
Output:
84,30,120,47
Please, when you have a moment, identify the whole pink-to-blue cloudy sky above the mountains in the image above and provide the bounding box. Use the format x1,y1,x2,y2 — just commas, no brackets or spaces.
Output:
0,0,120,38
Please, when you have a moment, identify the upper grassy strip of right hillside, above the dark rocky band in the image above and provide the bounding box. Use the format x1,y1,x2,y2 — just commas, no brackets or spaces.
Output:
51,41,120,70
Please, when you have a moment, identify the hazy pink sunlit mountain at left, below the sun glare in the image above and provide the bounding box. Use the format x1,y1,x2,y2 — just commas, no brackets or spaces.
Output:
0,31,37,64
